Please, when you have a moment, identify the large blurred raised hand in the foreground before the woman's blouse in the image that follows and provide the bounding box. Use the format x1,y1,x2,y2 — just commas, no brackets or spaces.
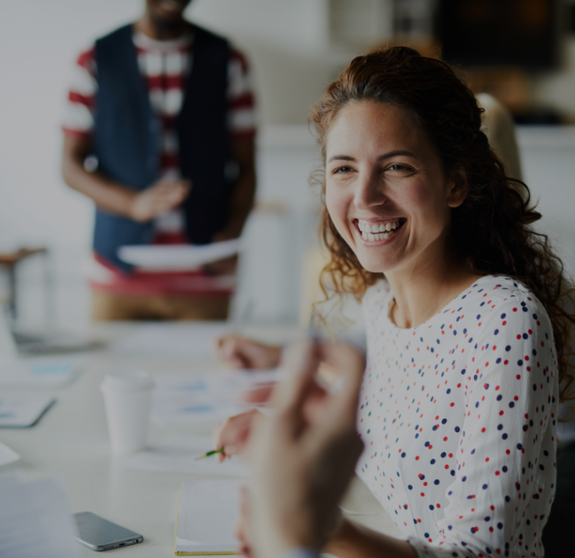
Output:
246,344,365,558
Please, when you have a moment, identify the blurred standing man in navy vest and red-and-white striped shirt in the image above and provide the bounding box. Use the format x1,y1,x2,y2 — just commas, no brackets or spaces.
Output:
62,0,255,320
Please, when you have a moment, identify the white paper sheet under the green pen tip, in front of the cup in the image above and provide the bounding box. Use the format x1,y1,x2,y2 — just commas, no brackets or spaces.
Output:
124,435,249,478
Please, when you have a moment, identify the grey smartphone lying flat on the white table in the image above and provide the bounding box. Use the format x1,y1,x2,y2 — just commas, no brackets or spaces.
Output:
74,512,144,552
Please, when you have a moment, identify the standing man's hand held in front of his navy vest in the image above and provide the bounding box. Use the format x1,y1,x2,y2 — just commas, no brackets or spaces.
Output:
129,180,191,223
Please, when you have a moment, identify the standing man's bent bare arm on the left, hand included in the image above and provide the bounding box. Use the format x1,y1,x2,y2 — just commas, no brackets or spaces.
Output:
62,134,190,222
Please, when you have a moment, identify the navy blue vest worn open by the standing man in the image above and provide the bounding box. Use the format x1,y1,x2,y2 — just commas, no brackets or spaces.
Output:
93,25,233,272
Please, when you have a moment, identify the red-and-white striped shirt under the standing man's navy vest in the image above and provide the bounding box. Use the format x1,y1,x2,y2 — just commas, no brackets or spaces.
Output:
62,31,256,296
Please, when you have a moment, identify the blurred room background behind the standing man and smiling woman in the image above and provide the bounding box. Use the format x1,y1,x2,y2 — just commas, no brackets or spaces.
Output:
0,0,575,329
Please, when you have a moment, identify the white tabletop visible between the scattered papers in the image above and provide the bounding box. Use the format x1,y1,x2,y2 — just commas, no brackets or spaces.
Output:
0,325,398,558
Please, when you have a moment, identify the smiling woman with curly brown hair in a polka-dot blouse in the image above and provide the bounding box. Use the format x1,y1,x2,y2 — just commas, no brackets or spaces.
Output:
311,47,574,558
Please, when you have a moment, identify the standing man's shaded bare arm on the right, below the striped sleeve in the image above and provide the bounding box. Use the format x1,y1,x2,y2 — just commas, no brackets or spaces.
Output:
214,138,256,241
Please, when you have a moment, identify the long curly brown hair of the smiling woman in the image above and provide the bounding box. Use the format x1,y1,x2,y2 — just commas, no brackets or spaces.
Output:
310,47,575,398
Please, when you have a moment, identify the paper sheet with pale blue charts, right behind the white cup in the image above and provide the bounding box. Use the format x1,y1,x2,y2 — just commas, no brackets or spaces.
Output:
152,369,282,425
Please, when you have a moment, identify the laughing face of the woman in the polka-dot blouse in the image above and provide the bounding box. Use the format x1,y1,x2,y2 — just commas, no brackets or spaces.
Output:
326,101,467,280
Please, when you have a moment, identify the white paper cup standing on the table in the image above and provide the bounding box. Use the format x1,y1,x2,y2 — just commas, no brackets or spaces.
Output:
100,372,154,455
